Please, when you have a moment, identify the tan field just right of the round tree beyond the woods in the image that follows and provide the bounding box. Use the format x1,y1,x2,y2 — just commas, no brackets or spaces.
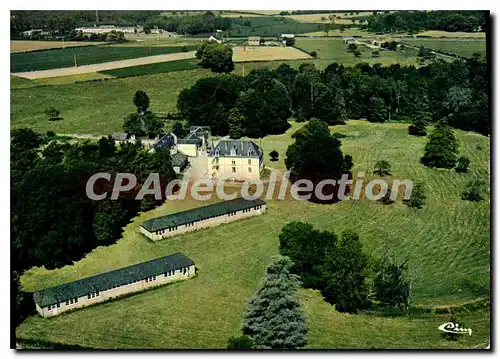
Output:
233,46,311,62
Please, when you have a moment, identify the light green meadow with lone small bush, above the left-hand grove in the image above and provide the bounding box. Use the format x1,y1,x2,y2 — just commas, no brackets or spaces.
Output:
11,69,212,135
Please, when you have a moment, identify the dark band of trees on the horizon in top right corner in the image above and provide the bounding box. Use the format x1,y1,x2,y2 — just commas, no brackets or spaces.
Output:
362,11,488,33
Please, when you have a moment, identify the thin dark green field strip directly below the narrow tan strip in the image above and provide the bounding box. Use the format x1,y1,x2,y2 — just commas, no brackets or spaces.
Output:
100,59,200,77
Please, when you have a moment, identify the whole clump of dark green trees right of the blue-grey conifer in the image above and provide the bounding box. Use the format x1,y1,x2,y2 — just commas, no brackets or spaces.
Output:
279,221,411,313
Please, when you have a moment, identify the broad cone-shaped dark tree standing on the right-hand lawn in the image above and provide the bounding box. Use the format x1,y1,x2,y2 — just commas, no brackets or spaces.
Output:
420,121,458,168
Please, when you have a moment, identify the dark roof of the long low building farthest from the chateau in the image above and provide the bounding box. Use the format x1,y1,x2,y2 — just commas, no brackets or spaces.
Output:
33,252,194,308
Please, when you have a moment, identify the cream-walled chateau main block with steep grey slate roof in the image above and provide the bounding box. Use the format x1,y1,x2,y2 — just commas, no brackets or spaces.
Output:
208,139,264,181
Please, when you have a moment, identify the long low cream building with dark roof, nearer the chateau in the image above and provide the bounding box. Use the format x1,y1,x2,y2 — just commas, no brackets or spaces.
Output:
140,198,266,241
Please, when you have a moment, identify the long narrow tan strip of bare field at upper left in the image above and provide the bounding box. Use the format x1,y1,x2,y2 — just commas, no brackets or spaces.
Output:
13,51,195,80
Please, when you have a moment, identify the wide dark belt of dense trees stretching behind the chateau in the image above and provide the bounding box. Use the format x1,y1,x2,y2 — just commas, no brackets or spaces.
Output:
172,56,490,137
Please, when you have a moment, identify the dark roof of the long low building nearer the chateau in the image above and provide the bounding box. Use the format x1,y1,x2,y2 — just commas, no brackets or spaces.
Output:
141,198,266,232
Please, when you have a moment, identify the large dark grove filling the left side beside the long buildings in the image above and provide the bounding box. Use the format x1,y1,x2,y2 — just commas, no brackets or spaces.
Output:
10,129,176,325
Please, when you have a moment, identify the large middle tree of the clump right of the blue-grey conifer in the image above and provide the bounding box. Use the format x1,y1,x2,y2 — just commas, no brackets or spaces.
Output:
321,231,369,313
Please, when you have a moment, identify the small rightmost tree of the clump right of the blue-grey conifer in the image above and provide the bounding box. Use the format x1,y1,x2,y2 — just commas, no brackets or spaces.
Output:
373,258,411,311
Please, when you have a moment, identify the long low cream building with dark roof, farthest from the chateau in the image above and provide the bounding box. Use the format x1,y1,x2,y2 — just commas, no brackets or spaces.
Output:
33,253,196,317
